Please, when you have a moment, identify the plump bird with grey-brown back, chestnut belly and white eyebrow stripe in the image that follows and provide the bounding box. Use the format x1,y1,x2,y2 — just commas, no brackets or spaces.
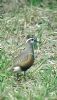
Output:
13,35,37,78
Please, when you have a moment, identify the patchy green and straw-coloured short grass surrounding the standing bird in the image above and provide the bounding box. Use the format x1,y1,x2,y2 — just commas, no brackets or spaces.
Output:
0,1,57,100
